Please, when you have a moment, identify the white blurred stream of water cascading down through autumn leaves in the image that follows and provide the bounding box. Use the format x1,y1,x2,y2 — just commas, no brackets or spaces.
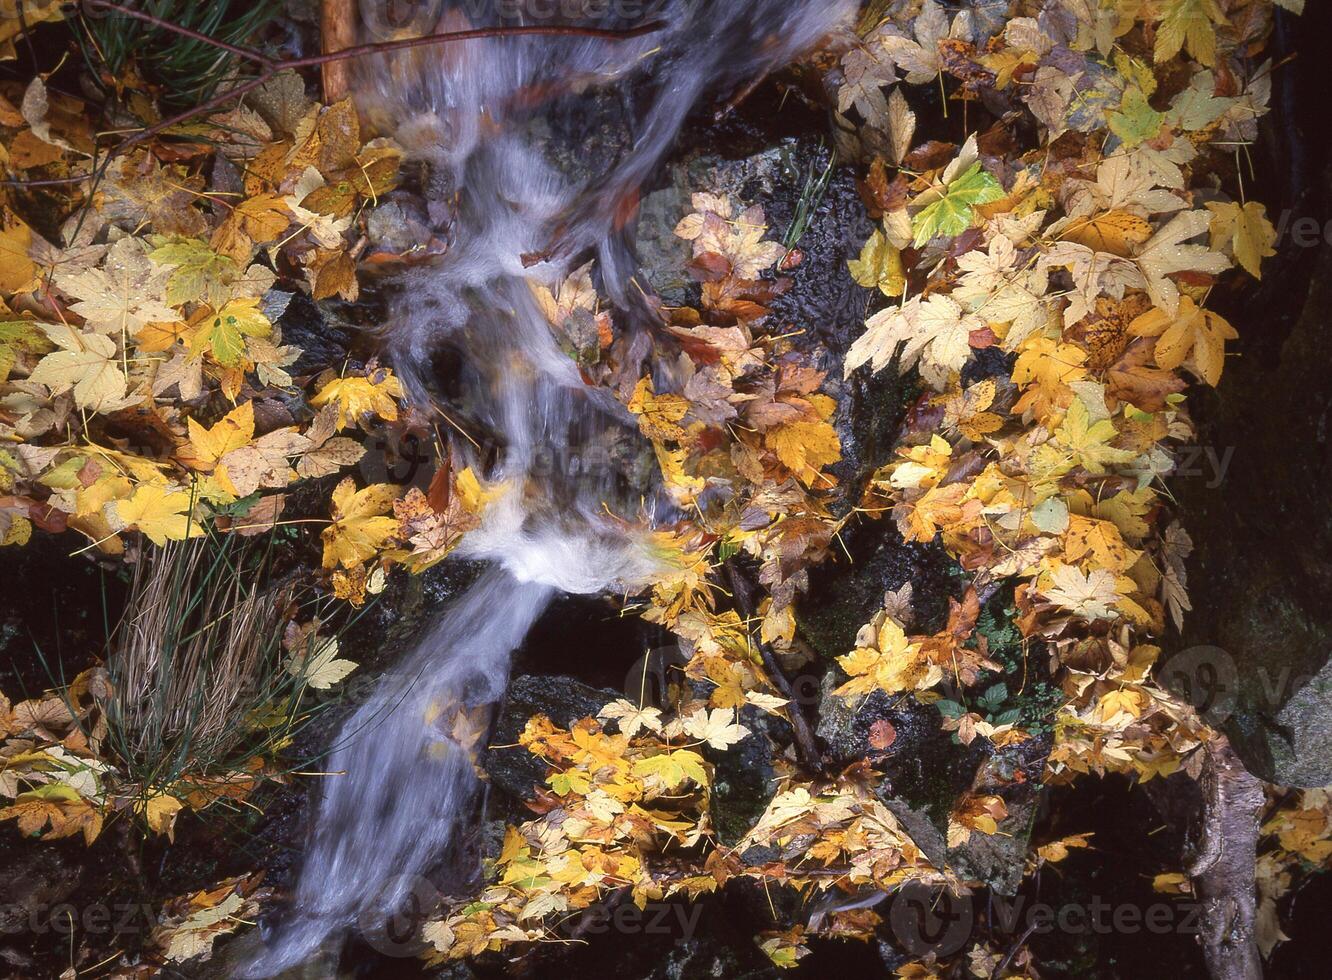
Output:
248,0,850,977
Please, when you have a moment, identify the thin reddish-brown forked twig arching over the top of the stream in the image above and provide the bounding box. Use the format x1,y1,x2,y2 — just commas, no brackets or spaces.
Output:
0,0,663,188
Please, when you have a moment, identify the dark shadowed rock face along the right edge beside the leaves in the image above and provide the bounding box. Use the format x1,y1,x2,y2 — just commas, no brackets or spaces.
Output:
1164,8,1332,786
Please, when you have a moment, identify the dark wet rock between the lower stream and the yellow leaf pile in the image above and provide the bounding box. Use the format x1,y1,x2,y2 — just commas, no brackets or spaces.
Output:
481,675,623,800
